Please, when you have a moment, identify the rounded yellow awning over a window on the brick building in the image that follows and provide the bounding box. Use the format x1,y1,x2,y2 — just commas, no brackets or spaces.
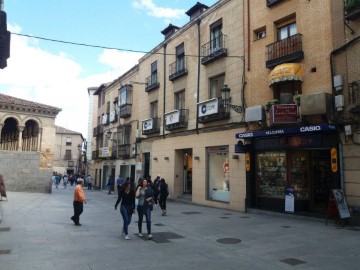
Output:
268,63,304,86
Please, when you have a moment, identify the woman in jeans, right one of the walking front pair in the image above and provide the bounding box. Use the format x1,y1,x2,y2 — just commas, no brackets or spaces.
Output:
135,179,154,239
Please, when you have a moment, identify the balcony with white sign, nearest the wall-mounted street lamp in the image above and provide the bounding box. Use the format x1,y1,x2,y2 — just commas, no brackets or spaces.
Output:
198,98,230,124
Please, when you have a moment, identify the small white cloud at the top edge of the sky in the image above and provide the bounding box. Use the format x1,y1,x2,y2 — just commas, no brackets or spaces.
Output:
132,0,186,21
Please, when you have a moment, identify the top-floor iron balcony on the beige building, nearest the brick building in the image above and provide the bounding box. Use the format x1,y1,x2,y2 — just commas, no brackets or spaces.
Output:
201,35,227,65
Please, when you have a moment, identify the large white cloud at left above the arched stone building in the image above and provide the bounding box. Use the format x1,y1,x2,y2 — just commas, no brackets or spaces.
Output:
0,24,142,137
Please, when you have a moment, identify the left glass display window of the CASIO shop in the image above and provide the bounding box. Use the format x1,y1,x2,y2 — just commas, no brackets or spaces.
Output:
257,152,286,198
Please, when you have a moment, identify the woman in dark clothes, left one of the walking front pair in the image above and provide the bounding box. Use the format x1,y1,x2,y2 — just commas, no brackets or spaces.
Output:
115,182,135,240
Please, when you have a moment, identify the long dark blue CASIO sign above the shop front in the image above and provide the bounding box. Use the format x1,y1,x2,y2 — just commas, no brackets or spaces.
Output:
235,124,336,139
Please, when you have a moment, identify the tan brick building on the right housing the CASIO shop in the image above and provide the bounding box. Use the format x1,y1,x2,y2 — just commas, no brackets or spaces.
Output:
240,0,360,214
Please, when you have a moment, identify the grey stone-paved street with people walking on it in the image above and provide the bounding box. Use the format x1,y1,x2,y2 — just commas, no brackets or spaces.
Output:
0,187,360,270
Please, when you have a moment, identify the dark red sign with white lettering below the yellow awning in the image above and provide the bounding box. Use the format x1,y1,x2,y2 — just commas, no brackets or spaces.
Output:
270,104,297,125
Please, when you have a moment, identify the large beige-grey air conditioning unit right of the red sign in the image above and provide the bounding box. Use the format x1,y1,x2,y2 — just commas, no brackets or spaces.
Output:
300,92,332,115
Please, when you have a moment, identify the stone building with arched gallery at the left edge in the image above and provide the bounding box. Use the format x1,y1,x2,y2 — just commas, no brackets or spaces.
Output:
0,94,61,192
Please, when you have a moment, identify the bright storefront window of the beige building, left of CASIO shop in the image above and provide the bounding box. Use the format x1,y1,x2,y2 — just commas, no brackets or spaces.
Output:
206,146,230,202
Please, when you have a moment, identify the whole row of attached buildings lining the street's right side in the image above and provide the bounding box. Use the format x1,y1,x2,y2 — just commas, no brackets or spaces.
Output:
89,0,360,214
